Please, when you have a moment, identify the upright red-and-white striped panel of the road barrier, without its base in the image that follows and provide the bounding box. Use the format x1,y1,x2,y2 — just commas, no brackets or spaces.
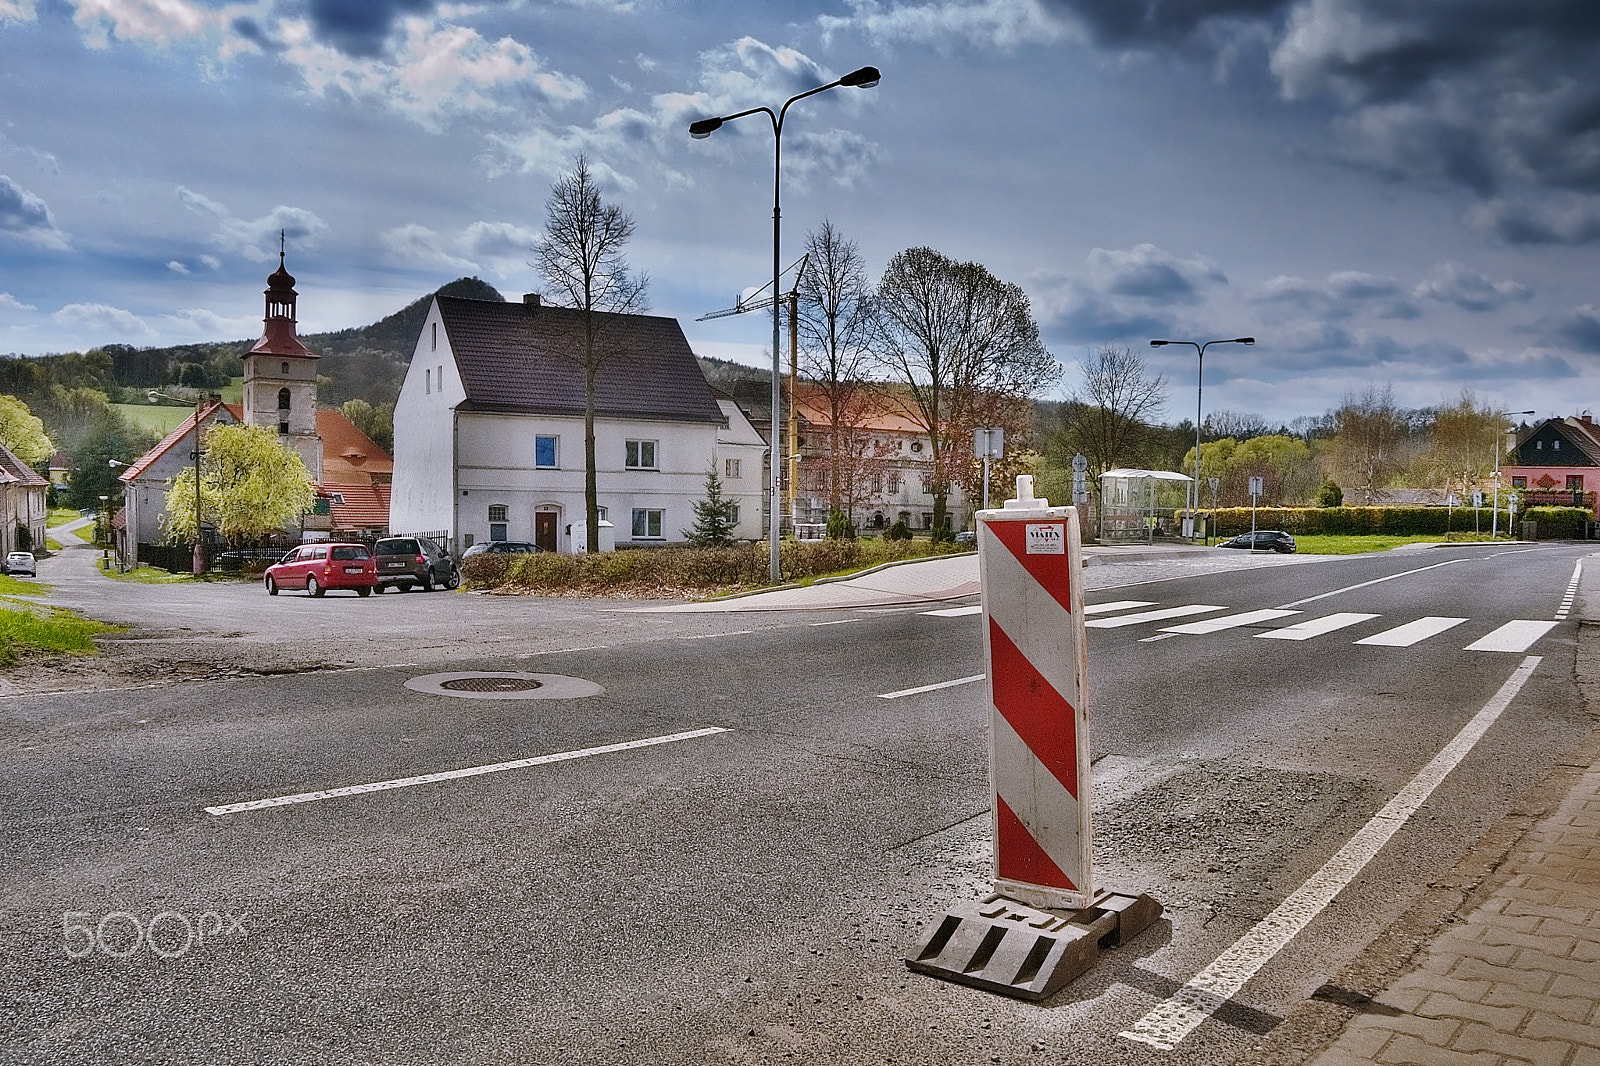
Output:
978,475,1093,908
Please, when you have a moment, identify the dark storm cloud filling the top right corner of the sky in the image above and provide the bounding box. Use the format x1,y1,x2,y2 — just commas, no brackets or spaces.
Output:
1046,0,1600,197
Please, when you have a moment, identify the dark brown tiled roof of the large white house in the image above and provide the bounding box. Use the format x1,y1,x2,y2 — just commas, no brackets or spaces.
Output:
435,296,722,424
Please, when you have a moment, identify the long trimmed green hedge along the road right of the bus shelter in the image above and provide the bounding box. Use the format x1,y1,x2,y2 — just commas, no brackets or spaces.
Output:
1208,507,1592,539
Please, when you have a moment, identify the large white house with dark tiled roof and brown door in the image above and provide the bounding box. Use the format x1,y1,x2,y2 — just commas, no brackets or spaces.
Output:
389,296,732,552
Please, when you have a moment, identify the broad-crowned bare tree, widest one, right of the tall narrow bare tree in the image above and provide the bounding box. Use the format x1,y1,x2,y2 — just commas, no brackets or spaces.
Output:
877,248,1061,530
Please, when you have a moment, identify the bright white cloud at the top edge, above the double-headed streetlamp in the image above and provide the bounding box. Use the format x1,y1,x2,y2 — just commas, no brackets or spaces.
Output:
818,0,1066,50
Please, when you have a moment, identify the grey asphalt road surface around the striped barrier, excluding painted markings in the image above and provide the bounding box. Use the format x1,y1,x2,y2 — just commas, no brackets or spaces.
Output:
0,546,1590,1066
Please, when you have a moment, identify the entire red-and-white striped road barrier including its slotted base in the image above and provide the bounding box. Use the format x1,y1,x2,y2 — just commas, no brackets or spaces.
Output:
906,475,1162,1000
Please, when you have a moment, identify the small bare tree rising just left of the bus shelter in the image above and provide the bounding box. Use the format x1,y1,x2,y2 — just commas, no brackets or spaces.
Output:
1053,344,1166,499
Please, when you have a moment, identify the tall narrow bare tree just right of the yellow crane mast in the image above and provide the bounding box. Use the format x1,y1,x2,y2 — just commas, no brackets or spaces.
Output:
798,219,872,512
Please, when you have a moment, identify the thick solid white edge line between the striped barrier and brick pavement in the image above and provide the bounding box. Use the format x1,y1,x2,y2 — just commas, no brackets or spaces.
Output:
1118,655,1539,1052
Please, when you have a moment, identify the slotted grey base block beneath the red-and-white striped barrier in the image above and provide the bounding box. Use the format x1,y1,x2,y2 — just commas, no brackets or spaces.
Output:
906,892,1162,1002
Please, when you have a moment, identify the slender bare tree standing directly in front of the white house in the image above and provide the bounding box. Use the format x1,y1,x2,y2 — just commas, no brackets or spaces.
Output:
530,155,650,552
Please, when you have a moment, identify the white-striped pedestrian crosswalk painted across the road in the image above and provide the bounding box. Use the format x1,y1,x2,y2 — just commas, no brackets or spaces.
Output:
923,600,1560,653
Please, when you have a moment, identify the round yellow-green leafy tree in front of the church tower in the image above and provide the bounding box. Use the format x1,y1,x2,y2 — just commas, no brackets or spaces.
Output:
165,424,317,544
